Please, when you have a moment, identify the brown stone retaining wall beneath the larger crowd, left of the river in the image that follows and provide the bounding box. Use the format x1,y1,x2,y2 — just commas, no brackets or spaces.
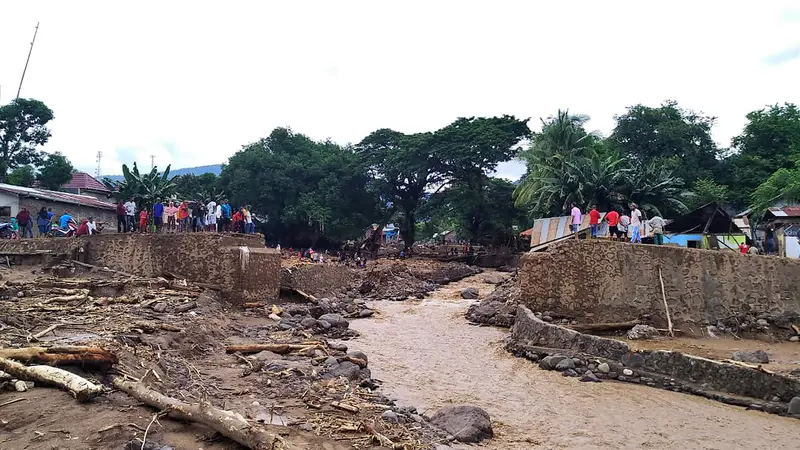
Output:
0,233,280,303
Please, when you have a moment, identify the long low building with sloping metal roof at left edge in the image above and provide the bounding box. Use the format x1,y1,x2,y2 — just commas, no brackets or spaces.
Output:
0,183,117,230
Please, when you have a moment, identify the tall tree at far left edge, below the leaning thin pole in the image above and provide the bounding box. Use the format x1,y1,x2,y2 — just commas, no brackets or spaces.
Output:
0,98,53,176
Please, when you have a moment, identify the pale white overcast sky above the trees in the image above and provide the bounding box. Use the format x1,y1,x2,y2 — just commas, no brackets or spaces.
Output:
0,0,800,179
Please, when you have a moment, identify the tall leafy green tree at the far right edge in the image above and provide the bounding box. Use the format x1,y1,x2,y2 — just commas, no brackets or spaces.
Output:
719,103,800,208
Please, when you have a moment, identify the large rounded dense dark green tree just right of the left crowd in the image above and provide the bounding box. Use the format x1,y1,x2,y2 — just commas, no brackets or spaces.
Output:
220,128,380,247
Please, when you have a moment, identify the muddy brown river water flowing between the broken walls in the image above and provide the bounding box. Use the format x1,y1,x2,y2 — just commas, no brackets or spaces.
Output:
349,275,800,450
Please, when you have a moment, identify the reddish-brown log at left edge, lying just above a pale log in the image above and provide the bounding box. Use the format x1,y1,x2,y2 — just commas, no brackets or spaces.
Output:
0,346,117,368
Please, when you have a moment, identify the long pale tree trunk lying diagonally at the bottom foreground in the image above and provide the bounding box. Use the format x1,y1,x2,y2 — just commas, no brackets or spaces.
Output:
112,377,288,450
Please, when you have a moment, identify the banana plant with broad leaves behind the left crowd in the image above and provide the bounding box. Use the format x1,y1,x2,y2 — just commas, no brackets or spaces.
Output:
103,163,176,209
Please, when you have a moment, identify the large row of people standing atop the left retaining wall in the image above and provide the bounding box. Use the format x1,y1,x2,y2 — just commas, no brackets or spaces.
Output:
112,199,256,234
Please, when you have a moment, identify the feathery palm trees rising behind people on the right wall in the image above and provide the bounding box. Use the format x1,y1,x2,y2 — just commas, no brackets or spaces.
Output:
514,111,691,217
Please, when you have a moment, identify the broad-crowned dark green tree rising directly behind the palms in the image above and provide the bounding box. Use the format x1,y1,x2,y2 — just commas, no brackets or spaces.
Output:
609,100,720,184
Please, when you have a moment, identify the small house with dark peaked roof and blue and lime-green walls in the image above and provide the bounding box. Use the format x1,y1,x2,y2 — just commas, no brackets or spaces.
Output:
664,202,746,250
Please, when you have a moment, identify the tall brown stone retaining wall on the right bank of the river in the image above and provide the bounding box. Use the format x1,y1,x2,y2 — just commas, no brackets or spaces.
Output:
519,240,800,326
